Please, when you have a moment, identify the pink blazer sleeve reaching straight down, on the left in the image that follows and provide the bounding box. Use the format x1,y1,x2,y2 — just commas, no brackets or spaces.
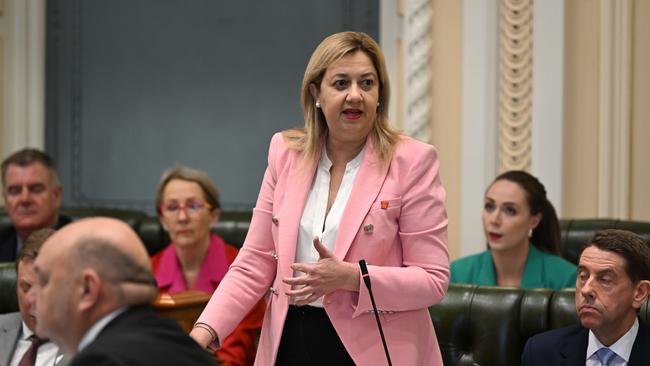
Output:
197,133,283,340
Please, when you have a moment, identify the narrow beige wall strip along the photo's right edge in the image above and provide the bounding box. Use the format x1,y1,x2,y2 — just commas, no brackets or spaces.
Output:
630,0,650,221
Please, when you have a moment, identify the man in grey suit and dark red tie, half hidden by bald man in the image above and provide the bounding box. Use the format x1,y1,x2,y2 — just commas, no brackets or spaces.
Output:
0,228,66,366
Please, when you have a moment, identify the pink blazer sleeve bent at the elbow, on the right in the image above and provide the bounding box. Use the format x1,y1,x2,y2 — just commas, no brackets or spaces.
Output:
353,143,449,317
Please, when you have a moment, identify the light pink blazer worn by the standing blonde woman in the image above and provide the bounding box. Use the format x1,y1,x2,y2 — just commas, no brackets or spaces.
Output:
198,133,449,366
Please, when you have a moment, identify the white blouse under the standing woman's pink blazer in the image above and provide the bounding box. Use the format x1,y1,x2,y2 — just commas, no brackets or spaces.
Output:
294,147,366,307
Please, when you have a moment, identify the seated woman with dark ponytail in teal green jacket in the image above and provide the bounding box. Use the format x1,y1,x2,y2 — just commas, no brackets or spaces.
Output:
451,170,576,290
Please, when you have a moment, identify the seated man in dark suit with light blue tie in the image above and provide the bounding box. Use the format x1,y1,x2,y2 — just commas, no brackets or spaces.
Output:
522,230,650,366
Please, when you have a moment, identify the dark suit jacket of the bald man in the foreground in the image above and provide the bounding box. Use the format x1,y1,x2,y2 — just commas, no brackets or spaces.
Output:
70,305,218,366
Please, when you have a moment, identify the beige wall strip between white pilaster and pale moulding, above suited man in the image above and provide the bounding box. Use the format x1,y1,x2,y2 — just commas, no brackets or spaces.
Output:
562,0,600,218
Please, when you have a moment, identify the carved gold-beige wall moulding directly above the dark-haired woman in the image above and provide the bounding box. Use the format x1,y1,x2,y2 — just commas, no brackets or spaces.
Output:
499,0,533,172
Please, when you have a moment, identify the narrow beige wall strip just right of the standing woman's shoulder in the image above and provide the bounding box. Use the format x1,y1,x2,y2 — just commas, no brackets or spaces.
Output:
431,0,463,258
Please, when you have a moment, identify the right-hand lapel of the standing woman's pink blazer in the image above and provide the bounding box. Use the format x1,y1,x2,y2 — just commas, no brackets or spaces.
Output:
334,137,388,260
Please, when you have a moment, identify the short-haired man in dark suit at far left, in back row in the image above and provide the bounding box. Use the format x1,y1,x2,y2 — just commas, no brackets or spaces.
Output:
0,148,70,262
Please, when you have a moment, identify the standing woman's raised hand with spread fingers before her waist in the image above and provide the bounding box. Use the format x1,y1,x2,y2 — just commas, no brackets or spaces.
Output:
282,237,359,305
